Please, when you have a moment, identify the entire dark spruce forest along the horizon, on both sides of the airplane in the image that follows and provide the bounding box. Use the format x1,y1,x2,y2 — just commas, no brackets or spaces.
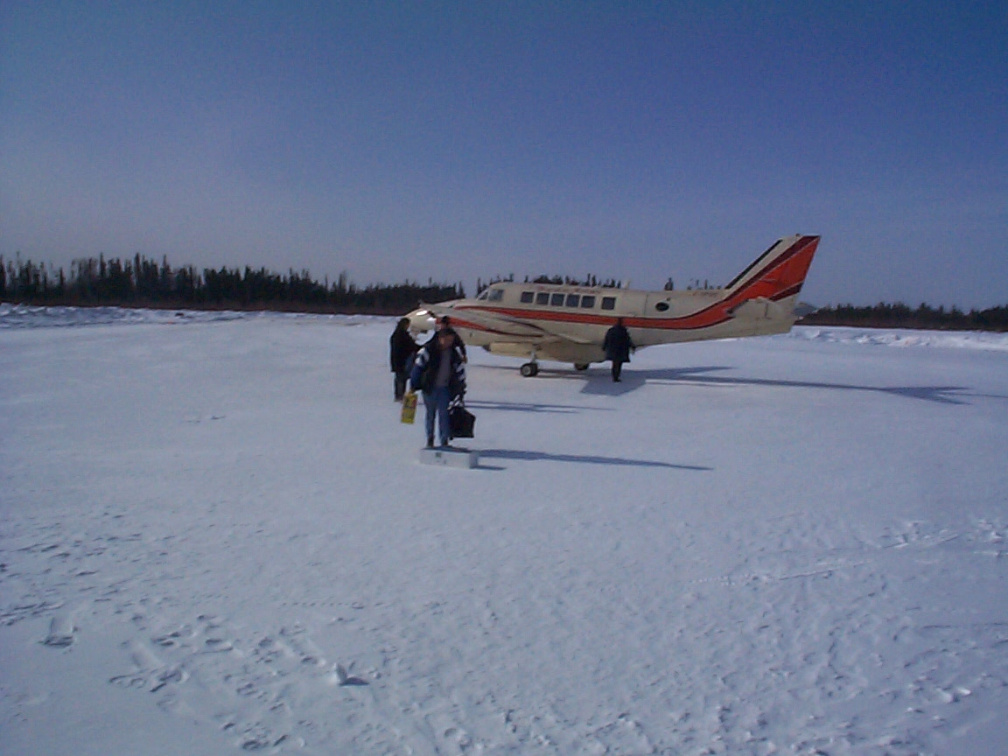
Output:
0,254,1008,332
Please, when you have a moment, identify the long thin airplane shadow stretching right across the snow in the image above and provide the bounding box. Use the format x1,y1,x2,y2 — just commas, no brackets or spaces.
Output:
568,365,970,404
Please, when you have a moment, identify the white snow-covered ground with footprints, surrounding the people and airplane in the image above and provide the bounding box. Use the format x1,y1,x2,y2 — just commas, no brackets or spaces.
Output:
0,305,1008,756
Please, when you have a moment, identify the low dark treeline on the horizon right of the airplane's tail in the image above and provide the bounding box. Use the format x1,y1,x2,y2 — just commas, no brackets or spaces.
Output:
798,302,1008,332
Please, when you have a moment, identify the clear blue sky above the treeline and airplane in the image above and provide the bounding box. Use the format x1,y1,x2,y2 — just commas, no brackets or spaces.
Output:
0,0,1008,308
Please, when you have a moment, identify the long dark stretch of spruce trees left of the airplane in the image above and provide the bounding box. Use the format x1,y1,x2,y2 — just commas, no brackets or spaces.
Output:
0,255,465,314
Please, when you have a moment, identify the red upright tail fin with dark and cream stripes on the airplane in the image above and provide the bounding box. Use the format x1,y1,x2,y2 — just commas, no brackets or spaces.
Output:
725,234,820,306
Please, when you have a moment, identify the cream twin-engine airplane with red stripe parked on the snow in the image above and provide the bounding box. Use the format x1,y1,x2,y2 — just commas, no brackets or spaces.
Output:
405,234,820,377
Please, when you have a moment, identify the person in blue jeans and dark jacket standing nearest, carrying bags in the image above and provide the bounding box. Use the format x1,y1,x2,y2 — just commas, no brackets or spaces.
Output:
409,328,466,447
